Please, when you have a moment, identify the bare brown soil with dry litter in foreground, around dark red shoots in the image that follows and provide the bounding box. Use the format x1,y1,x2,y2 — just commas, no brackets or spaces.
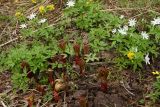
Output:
0,66,160,107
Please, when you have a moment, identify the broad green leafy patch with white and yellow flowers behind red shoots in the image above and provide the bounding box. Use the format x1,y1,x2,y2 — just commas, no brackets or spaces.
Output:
0,0,160,99
